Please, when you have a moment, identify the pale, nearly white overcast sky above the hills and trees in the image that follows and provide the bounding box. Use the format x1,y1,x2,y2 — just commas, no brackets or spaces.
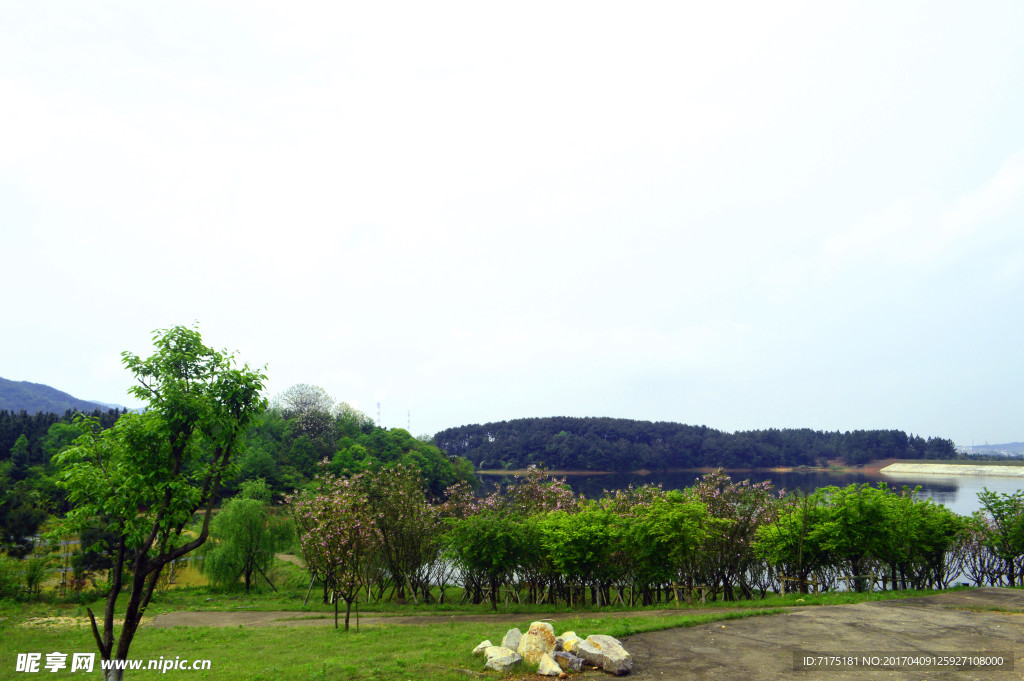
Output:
0,0,1024,445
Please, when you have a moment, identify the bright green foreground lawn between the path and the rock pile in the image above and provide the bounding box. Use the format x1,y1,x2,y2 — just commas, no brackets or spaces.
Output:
0,609,777,681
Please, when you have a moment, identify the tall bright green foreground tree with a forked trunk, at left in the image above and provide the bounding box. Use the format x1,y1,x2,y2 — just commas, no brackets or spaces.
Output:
56,327,266,679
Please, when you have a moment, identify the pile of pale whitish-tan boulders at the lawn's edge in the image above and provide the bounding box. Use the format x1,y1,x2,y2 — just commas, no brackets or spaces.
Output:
473,622,633,676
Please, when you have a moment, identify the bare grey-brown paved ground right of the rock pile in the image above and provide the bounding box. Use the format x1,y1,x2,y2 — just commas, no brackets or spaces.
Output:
624,589,1024,681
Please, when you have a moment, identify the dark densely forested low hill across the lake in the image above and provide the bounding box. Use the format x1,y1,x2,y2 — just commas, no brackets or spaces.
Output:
434,417,956,470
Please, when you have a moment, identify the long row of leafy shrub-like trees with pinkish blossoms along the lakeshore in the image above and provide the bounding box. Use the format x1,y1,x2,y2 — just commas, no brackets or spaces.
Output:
289,468,1024,627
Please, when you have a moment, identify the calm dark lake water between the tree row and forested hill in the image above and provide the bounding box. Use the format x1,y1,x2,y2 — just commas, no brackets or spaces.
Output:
480,472,1024,515
